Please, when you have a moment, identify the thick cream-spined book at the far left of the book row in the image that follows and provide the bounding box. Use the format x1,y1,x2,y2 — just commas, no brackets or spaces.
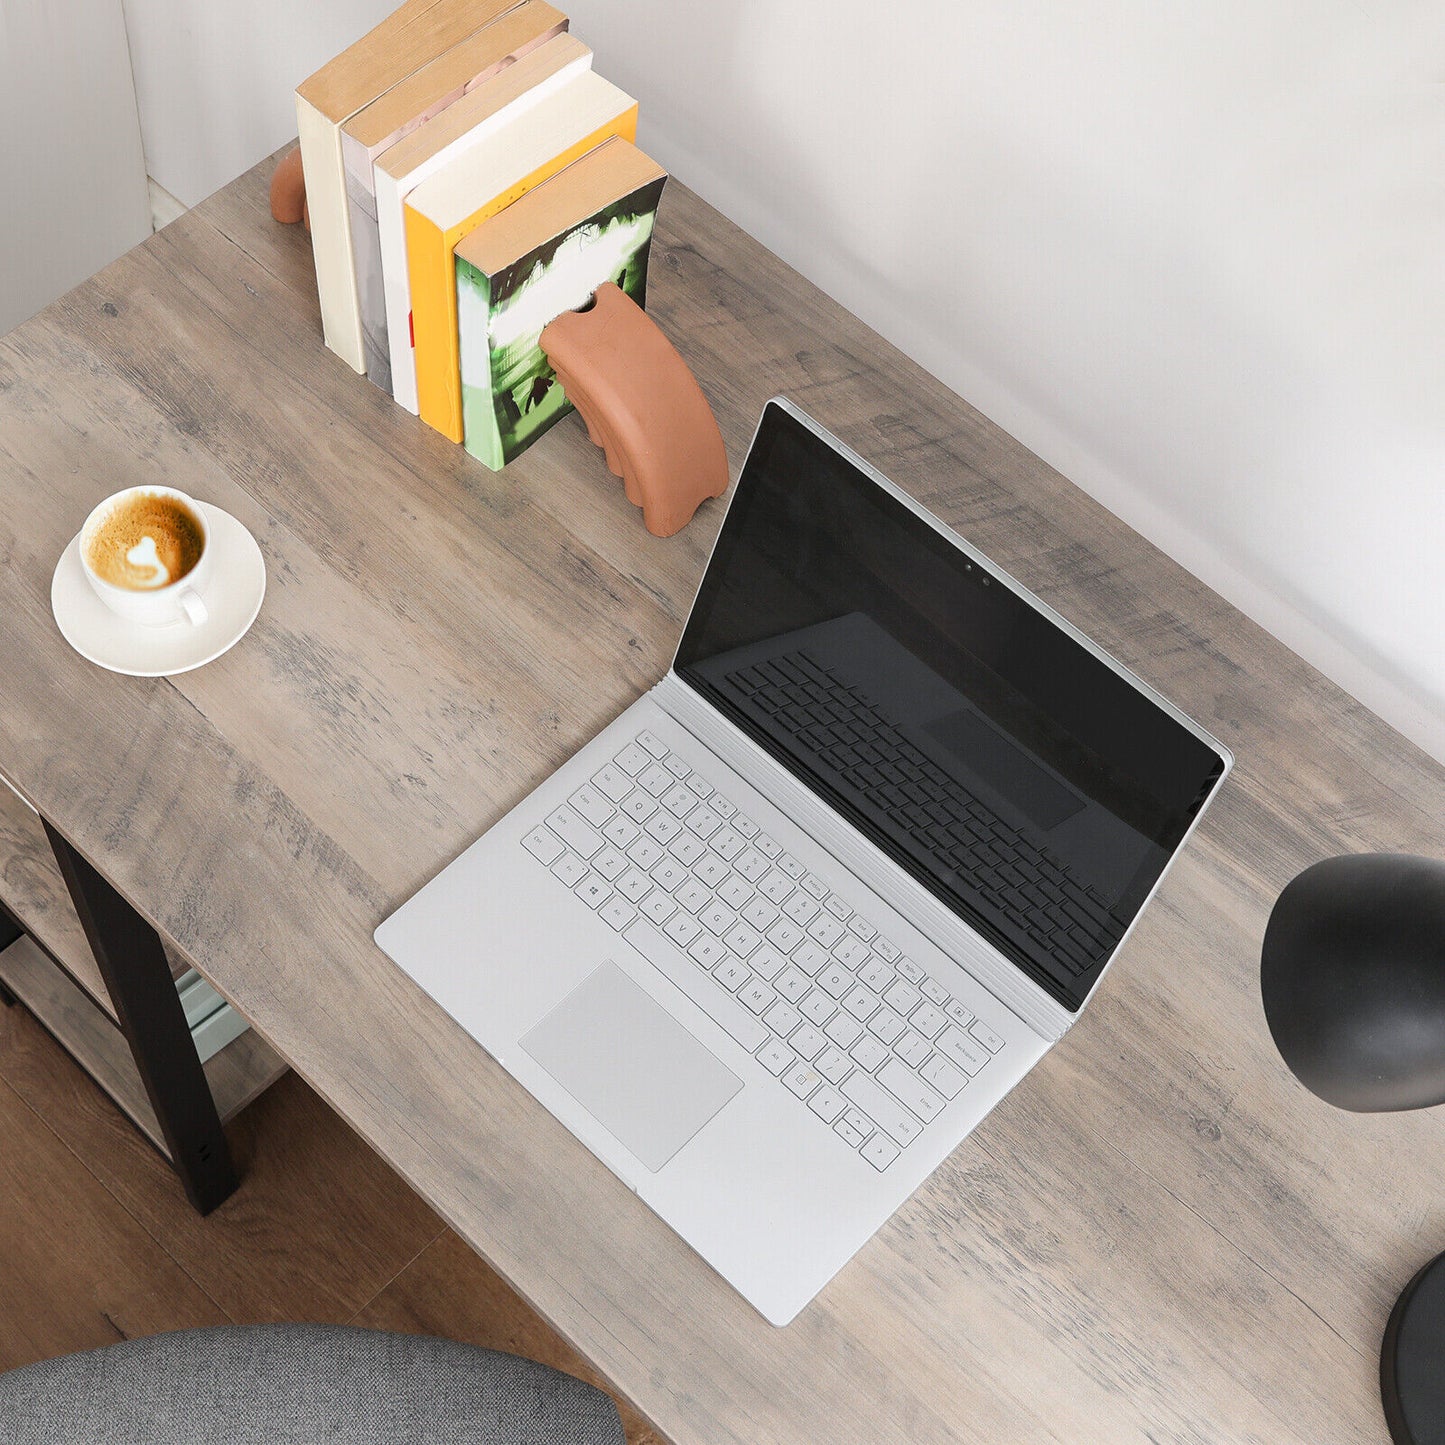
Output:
296,0,517,371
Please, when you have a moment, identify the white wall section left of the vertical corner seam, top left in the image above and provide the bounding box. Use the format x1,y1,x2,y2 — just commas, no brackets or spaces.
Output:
0,0,150,332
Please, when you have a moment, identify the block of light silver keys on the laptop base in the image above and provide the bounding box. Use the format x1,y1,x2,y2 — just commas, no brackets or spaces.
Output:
522,731,1004,1170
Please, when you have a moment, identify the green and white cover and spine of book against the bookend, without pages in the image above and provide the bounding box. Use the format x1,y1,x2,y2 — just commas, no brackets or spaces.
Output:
457,168,666,471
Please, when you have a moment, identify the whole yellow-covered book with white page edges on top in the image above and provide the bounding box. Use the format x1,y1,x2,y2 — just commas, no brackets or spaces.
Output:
406,71,637,442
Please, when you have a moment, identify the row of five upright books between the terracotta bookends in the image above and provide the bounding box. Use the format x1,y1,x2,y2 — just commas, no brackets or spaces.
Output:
296,0,666,468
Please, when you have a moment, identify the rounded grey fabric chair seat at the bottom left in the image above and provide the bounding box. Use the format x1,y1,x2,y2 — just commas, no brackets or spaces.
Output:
0,1325,623,1445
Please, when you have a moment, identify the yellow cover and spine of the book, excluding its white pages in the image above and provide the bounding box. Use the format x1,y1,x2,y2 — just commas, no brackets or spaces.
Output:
406,104,637,442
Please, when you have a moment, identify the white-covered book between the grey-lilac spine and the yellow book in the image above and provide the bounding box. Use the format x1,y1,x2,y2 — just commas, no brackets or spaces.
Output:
374,35,592,416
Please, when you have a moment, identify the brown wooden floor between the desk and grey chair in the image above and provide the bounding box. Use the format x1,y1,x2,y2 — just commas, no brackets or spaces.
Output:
0,1006,660,1445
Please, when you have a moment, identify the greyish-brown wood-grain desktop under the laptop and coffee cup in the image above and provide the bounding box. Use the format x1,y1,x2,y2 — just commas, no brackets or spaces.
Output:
0,152,1445,1445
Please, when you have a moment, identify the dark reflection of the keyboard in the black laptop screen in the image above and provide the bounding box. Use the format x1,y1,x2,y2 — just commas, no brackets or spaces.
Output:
727,652,1124,977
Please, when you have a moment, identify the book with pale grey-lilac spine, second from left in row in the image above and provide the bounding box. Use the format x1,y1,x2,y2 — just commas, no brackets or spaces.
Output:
341,0,566,392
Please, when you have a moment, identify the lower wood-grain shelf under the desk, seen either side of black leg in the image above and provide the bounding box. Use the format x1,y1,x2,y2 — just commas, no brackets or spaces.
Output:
0,938,286,1157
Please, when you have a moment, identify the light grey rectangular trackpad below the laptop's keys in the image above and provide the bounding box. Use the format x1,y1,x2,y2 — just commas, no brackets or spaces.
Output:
522,959,743,1173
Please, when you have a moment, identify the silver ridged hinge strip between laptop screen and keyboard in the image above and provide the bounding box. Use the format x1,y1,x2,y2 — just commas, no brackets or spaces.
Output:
652,670,1075,1042
